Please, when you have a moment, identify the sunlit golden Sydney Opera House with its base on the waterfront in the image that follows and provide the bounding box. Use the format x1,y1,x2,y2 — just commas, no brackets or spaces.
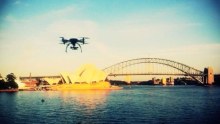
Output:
51,64,121,90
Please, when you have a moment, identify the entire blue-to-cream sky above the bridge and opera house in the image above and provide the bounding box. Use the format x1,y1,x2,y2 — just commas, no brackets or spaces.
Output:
0,0,220,76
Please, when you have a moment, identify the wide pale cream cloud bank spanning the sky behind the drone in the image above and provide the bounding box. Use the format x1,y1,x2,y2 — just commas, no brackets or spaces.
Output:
0,1,220,75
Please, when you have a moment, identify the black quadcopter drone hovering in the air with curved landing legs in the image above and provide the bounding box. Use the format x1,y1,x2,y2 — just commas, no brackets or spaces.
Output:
60,37,89,52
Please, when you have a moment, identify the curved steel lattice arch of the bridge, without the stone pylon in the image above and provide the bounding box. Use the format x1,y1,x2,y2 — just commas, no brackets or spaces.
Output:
103,58,205,84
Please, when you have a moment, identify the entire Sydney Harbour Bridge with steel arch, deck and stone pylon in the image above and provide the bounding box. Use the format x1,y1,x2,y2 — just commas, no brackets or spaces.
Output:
20,58,214,85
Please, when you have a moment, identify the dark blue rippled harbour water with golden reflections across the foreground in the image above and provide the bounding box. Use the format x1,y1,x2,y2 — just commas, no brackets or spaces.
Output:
0,85,220,124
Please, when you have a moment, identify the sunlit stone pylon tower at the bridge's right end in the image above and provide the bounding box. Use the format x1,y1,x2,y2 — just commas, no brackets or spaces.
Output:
203,67,214,85
